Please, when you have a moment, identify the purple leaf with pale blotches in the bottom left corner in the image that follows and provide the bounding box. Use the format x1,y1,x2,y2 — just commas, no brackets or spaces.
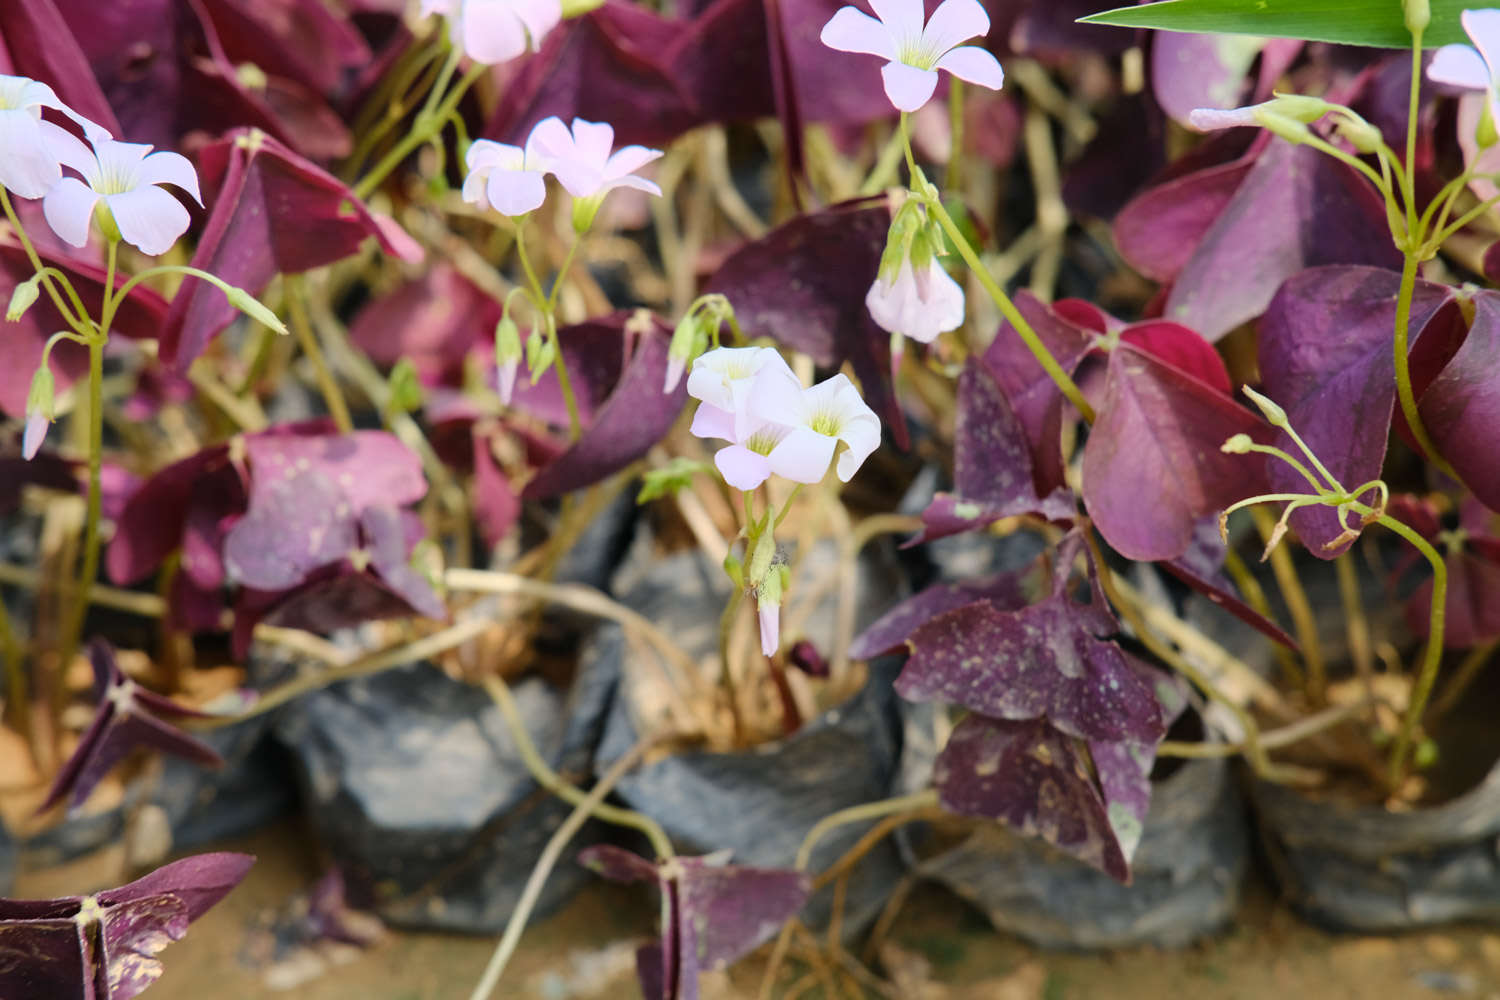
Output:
0,853,255,1000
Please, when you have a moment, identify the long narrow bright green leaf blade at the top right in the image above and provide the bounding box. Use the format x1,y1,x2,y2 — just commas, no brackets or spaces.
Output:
1079,0,1482,48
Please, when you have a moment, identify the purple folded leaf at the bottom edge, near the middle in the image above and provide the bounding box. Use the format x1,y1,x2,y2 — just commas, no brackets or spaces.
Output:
579,844,812,1000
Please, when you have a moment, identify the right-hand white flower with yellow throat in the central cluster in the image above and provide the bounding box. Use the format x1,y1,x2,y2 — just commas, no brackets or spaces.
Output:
749,373,881,483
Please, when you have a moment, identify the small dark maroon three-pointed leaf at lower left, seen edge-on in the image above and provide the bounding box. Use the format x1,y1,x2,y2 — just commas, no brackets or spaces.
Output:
38,639,224,813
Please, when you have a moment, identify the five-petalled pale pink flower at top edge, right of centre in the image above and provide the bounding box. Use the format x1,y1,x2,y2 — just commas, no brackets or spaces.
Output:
819,0,1005,111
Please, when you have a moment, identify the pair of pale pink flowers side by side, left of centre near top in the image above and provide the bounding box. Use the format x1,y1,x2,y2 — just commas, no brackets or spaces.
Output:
464,117,662,220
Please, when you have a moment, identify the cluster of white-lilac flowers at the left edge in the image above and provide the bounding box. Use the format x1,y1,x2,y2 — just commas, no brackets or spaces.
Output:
0,76,203,256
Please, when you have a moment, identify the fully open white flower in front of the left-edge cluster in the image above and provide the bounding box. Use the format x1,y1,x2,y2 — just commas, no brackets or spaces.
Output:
42,138,203,256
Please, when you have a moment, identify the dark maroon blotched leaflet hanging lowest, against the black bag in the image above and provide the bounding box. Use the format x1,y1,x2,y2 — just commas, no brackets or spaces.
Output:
933,715,1130,882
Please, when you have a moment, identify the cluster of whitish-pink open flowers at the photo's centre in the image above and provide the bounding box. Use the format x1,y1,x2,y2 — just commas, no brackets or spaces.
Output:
687,348,881,490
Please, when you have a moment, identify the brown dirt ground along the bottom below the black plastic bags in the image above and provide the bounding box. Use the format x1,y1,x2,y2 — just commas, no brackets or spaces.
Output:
18,822,1500,1000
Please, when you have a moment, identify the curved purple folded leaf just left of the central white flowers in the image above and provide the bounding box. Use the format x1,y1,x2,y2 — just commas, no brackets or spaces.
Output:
522,316,687,499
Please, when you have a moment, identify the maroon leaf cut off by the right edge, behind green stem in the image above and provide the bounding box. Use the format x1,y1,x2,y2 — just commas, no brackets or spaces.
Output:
1413,291,1500,510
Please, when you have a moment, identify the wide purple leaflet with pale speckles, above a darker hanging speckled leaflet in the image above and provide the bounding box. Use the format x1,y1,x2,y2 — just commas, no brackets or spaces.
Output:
896,597,1166,742
